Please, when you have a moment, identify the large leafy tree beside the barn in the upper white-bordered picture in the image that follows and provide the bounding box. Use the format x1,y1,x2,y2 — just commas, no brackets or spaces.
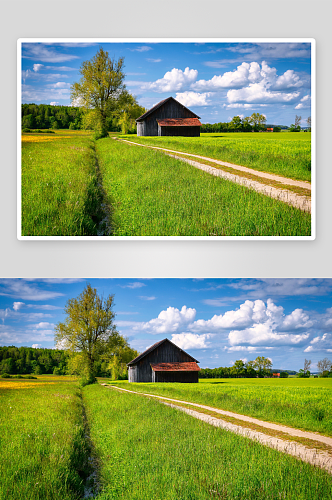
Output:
70,48,128,137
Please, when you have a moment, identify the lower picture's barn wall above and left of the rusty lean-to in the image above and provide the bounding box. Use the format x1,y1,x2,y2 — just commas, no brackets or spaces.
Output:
135,342,192,382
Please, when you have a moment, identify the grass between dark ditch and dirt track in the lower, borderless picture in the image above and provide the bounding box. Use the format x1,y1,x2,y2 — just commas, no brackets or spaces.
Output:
84,386,332,500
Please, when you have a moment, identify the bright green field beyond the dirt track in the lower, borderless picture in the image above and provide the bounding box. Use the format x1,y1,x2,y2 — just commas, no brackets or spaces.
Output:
112,379,332,436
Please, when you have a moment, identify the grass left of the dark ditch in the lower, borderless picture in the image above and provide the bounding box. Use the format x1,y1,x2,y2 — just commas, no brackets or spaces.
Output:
0,376,88,500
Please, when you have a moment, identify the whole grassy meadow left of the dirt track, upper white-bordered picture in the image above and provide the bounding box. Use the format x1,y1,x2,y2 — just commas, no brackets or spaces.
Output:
21,130,311,236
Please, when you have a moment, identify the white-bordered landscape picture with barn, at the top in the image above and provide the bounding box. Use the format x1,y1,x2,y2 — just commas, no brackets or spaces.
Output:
17,38,316,241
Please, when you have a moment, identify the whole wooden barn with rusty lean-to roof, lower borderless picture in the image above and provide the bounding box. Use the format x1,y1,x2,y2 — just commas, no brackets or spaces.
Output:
127,339,200,383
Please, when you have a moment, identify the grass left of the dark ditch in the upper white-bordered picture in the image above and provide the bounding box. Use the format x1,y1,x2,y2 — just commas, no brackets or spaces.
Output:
21,131,101,236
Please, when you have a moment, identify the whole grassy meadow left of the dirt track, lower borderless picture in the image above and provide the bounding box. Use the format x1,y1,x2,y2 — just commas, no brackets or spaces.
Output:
0,375,332,500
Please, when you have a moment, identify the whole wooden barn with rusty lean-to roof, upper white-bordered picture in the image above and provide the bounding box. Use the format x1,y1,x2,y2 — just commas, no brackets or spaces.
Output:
136,97,202,137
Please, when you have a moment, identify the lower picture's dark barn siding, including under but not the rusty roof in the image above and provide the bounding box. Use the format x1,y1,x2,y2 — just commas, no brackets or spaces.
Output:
128,342,198,382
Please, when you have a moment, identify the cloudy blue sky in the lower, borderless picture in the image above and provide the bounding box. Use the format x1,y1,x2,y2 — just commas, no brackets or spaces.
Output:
0,278,332,371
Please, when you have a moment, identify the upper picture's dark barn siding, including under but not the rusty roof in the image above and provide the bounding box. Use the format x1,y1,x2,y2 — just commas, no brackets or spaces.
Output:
137,99,200,137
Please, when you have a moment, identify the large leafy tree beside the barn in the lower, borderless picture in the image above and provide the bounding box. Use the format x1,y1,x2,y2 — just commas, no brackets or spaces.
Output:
55,284,124,382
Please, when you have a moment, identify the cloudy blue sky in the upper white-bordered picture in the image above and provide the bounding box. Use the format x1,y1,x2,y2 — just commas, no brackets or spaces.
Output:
22,41,311,126
